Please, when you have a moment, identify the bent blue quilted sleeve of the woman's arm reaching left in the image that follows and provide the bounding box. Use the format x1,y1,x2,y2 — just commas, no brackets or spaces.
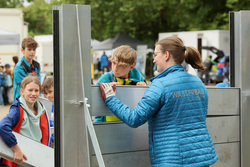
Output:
105,82,164,127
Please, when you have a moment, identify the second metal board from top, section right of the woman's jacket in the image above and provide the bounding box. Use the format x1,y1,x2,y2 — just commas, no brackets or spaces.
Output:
206,116,240,144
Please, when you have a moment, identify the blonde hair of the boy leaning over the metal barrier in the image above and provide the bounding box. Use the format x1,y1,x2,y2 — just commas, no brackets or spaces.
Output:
109,45,137,66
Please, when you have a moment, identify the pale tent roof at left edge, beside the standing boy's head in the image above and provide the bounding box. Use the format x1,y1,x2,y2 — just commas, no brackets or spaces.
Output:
0,29,20,45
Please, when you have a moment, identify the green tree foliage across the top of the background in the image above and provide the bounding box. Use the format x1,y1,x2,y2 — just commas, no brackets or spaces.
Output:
0,0,250,43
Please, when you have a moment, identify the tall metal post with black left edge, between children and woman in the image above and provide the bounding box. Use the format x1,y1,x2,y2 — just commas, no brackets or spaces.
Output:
53,5,91,167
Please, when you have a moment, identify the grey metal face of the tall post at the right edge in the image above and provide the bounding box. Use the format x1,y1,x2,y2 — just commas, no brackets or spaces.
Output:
234,11,250,167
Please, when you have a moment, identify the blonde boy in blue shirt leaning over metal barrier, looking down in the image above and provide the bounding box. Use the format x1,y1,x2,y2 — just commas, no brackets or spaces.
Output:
95,45,146,122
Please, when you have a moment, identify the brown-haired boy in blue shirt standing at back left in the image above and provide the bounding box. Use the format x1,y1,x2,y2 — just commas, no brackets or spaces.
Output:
13,37,40,101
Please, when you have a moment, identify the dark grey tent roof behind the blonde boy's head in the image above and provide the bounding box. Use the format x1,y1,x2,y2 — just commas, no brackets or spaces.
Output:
93,33,152,50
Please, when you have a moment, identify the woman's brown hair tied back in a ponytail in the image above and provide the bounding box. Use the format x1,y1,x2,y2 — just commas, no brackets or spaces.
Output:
155,36,205,70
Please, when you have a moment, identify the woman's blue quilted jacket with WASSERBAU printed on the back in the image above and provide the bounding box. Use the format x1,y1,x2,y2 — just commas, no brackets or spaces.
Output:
105,65,218,167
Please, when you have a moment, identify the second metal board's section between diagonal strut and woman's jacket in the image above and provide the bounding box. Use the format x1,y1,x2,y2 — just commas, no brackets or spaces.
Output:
94,123,148,154
